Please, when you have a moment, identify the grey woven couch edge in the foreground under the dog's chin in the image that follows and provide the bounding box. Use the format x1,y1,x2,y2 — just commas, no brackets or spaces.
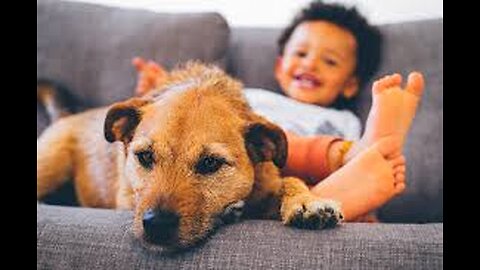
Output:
37,205,443,269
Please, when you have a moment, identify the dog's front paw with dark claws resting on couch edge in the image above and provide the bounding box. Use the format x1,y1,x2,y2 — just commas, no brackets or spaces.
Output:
283,200,343,230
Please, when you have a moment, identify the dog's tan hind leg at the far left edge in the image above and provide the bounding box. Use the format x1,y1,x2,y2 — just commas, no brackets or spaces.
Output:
37,119,74,200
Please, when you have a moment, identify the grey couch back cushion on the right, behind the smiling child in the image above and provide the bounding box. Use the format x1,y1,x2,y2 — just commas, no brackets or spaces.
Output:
227,19,443,222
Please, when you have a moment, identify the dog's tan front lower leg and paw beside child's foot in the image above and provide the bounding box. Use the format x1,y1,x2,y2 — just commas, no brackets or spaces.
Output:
280,177,343,229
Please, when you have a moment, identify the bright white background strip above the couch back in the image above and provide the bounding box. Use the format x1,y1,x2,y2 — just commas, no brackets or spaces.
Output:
63,0,443,27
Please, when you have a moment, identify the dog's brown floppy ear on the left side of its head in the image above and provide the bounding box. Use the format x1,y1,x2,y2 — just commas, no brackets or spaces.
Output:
103,98,148,143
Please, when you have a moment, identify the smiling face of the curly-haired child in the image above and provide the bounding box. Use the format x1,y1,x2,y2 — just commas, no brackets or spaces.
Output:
275,21,358,106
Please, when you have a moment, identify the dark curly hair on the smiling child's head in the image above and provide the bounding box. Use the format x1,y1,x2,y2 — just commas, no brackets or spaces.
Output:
278,0,382,87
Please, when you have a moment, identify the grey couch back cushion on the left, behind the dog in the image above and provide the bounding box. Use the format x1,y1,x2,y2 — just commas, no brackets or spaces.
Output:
37,0,229,134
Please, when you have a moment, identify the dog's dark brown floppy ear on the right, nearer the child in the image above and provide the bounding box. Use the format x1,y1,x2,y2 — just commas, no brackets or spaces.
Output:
244,119,288,168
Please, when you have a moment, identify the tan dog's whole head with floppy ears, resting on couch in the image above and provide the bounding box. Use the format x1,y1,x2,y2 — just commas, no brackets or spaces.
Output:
104,61,287,247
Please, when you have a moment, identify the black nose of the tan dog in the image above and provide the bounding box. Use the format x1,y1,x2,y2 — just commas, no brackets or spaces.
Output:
143,209,180,244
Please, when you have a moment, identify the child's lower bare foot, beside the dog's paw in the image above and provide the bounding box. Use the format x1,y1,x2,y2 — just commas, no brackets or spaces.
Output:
311,136,405,221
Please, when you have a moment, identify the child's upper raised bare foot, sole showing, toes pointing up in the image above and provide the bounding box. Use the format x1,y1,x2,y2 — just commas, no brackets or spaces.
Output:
344,72,424,162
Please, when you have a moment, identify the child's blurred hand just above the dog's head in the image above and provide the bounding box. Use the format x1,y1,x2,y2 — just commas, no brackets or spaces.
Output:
132,57,167,96
